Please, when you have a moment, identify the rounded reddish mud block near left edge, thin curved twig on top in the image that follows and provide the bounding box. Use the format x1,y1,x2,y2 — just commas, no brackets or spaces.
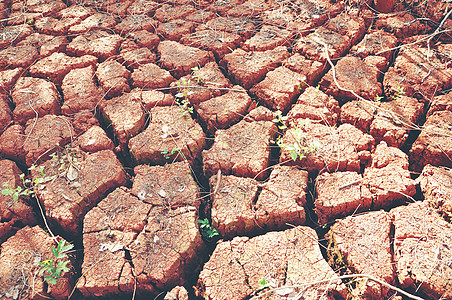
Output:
11,77,60,124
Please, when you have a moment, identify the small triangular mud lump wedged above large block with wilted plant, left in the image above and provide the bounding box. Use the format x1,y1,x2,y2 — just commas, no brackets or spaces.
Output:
76,125,115,153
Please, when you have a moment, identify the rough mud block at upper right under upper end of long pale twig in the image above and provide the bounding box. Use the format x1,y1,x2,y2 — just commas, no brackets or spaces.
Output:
293,27,352,64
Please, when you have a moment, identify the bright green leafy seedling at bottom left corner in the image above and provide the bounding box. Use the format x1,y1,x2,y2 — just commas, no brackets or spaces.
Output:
39,240,74,285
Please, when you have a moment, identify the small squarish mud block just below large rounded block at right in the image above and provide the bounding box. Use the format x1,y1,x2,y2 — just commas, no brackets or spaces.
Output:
340,100,380,132
